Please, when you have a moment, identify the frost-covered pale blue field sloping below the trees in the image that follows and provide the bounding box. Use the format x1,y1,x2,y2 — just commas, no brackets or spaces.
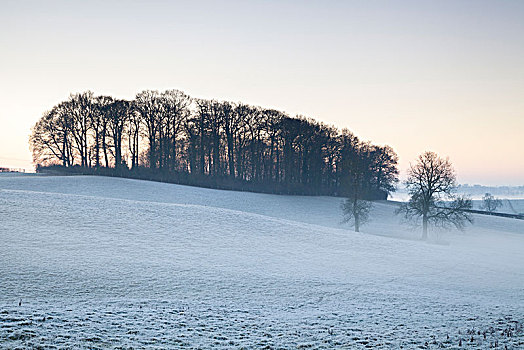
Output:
0,174,524,349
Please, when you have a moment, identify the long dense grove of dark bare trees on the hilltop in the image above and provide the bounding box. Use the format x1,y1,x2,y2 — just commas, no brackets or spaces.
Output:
30,90,398,199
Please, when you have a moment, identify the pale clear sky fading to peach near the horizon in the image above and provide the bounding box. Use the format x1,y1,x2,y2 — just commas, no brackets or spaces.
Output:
0,0,524,185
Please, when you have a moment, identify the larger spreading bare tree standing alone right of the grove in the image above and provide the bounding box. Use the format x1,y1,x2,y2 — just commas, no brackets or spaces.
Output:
397,152,473,240
